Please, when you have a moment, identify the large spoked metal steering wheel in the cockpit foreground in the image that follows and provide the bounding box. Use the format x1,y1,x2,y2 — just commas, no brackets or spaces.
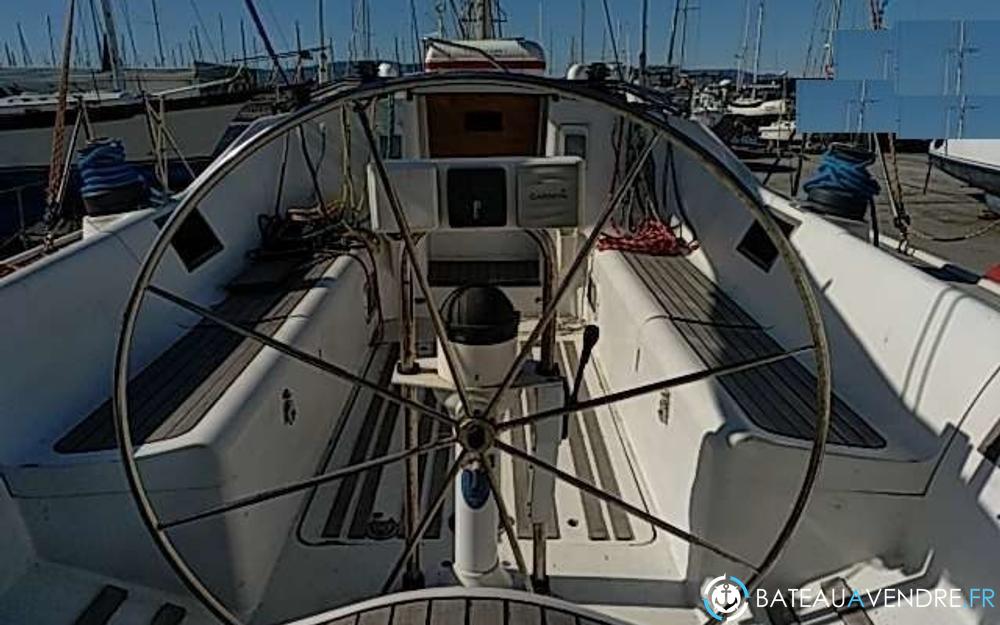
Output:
113,72,831,625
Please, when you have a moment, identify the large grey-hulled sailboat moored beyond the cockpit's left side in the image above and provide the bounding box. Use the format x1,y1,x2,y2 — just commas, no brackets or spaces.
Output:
0,0,304,254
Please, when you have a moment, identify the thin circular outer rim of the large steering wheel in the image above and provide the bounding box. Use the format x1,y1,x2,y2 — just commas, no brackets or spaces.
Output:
113,73,832,625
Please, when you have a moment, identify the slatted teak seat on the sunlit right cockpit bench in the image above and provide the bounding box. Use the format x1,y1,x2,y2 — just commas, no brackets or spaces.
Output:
623,254,885,448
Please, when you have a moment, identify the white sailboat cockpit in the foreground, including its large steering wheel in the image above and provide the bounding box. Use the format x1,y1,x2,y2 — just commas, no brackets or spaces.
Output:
0,37,1000,625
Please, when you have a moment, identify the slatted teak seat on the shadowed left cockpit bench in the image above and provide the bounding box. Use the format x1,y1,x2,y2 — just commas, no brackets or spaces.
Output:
55,258,334,454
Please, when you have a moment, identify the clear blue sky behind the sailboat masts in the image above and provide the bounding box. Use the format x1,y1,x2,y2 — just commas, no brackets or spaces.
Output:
0,0,1000,74
